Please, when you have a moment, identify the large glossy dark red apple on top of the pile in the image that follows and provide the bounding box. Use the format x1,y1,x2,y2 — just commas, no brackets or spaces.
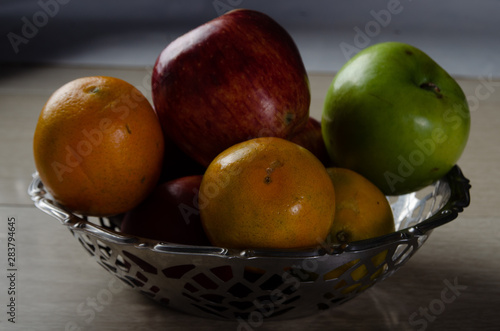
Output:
152,9,311,166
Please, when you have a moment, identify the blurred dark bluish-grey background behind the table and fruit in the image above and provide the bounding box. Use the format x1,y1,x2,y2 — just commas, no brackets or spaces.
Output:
0,0,500,78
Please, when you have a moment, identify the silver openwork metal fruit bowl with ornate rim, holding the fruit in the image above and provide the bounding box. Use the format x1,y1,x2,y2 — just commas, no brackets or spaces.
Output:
28,166,470,320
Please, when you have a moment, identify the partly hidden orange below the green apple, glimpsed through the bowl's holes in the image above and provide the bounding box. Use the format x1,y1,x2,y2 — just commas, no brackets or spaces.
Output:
324,167,395,286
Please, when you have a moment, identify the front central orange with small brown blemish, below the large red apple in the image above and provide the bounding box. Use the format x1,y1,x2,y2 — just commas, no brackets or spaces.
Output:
198,137,335,249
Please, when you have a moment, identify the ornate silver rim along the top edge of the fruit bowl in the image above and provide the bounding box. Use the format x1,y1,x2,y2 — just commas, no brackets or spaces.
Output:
28,165,471,259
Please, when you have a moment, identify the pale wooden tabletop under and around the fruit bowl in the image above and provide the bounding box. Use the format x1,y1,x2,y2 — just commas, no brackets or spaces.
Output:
0,66,500,331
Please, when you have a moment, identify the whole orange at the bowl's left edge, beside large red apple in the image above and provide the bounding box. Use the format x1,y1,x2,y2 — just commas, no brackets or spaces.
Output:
33,76,164,216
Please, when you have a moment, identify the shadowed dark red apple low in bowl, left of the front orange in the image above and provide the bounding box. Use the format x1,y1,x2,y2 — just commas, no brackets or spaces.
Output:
121,175,210,246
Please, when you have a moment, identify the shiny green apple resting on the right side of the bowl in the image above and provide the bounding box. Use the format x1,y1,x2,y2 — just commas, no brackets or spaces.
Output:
321,42,470,195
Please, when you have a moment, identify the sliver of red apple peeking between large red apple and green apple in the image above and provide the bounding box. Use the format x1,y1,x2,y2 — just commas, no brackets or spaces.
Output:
290,117,332,167
